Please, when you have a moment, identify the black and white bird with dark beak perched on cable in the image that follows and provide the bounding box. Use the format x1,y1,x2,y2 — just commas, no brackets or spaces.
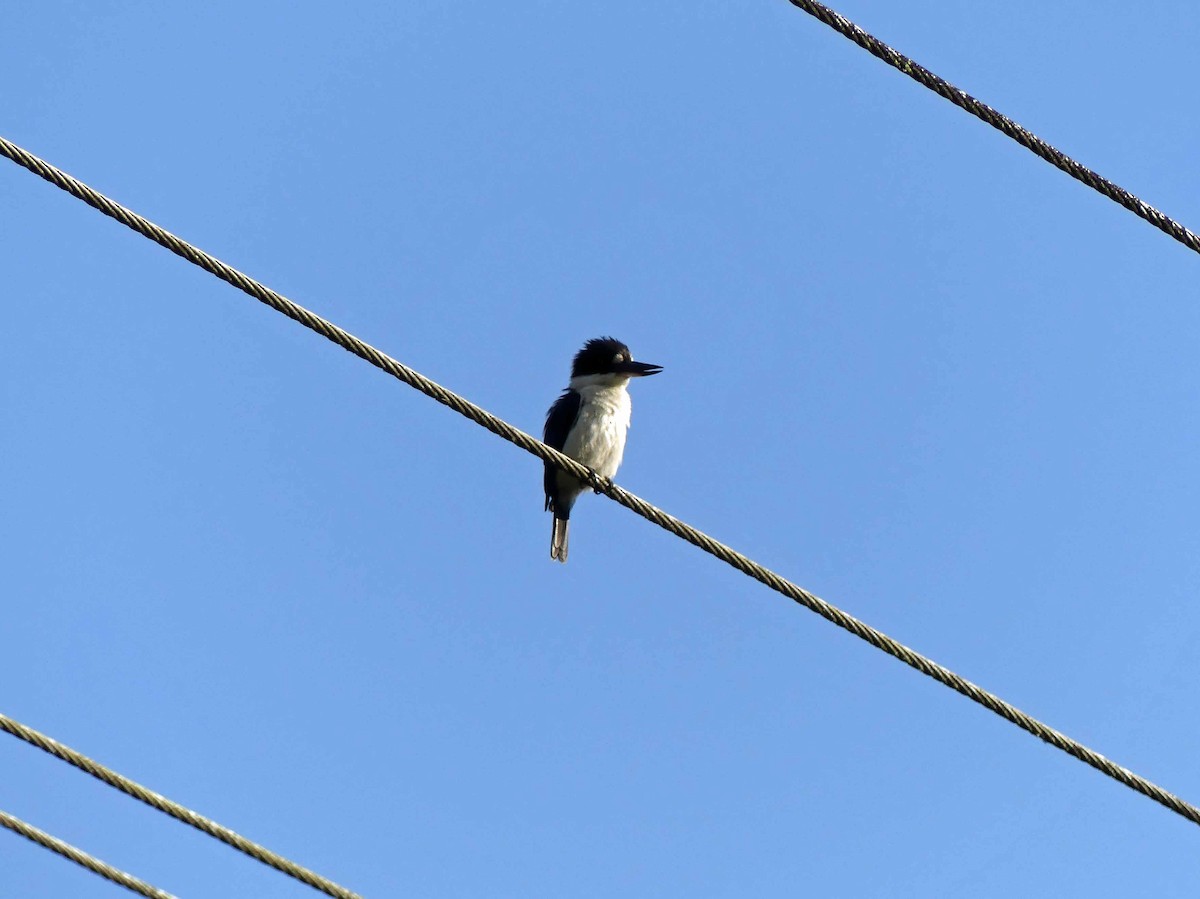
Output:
542,337,662,563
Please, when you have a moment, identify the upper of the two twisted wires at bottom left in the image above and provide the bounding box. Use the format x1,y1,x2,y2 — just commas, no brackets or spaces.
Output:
0,714,362,899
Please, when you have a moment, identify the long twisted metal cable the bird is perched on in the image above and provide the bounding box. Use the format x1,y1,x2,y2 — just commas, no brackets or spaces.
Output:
0,138,1200,825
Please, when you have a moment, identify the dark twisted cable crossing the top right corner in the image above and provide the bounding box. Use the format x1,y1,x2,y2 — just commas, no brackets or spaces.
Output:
787,0,1200,253
